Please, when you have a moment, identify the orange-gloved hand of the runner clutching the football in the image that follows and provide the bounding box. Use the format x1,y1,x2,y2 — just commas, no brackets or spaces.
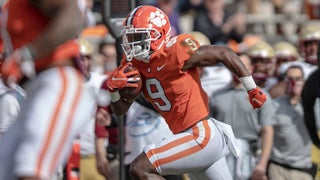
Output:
107,62,139,91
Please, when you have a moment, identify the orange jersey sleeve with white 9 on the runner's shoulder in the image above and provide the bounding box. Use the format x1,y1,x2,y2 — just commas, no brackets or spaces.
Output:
176,34,200,69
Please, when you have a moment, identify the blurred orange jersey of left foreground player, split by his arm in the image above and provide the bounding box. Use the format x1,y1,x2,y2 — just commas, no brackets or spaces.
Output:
4,0,79,70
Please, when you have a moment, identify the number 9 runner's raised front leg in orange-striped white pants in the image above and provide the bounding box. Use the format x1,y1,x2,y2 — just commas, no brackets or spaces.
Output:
131,120,227,178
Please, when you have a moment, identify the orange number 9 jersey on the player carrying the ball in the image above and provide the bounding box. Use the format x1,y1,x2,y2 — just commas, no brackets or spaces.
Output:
123,34,209,133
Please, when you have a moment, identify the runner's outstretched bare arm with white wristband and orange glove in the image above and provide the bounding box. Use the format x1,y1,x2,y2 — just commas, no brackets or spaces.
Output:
182,45,267,109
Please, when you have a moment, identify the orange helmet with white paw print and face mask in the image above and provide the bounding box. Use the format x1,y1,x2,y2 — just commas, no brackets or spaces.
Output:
121,5,171,62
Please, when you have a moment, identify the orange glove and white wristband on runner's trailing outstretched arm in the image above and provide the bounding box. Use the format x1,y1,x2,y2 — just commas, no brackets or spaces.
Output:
239,76,267,109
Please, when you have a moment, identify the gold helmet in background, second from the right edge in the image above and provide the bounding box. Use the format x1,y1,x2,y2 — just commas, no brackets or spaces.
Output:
273,41,299,58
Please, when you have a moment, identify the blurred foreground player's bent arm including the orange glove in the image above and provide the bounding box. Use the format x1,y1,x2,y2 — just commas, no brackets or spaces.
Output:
1,0,85,87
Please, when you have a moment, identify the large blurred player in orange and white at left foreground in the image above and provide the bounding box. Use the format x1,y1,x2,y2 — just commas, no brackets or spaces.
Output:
0,0,95,180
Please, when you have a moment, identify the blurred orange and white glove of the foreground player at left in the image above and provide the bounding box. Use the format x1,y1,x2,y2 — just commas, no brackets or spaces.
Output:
1,46,36,87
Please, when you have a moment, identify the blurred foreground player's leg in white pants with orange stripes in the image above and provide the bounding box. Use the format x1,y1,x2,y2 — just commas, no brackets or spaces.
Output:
14,67,94,179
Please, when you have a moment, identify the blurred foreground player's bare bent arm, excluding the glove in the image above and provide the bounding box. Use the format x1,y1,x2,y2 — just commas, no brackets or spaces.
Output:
30,0,85,59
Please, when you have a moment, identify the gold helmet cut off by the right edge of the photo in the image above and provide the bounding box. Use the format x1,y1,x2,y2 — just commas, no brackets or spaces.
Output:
299,23,320,41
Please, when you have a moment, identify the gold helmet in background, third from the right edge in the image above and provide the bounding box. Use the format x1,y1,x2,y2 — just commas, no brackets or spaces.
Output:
247,41,274,59
